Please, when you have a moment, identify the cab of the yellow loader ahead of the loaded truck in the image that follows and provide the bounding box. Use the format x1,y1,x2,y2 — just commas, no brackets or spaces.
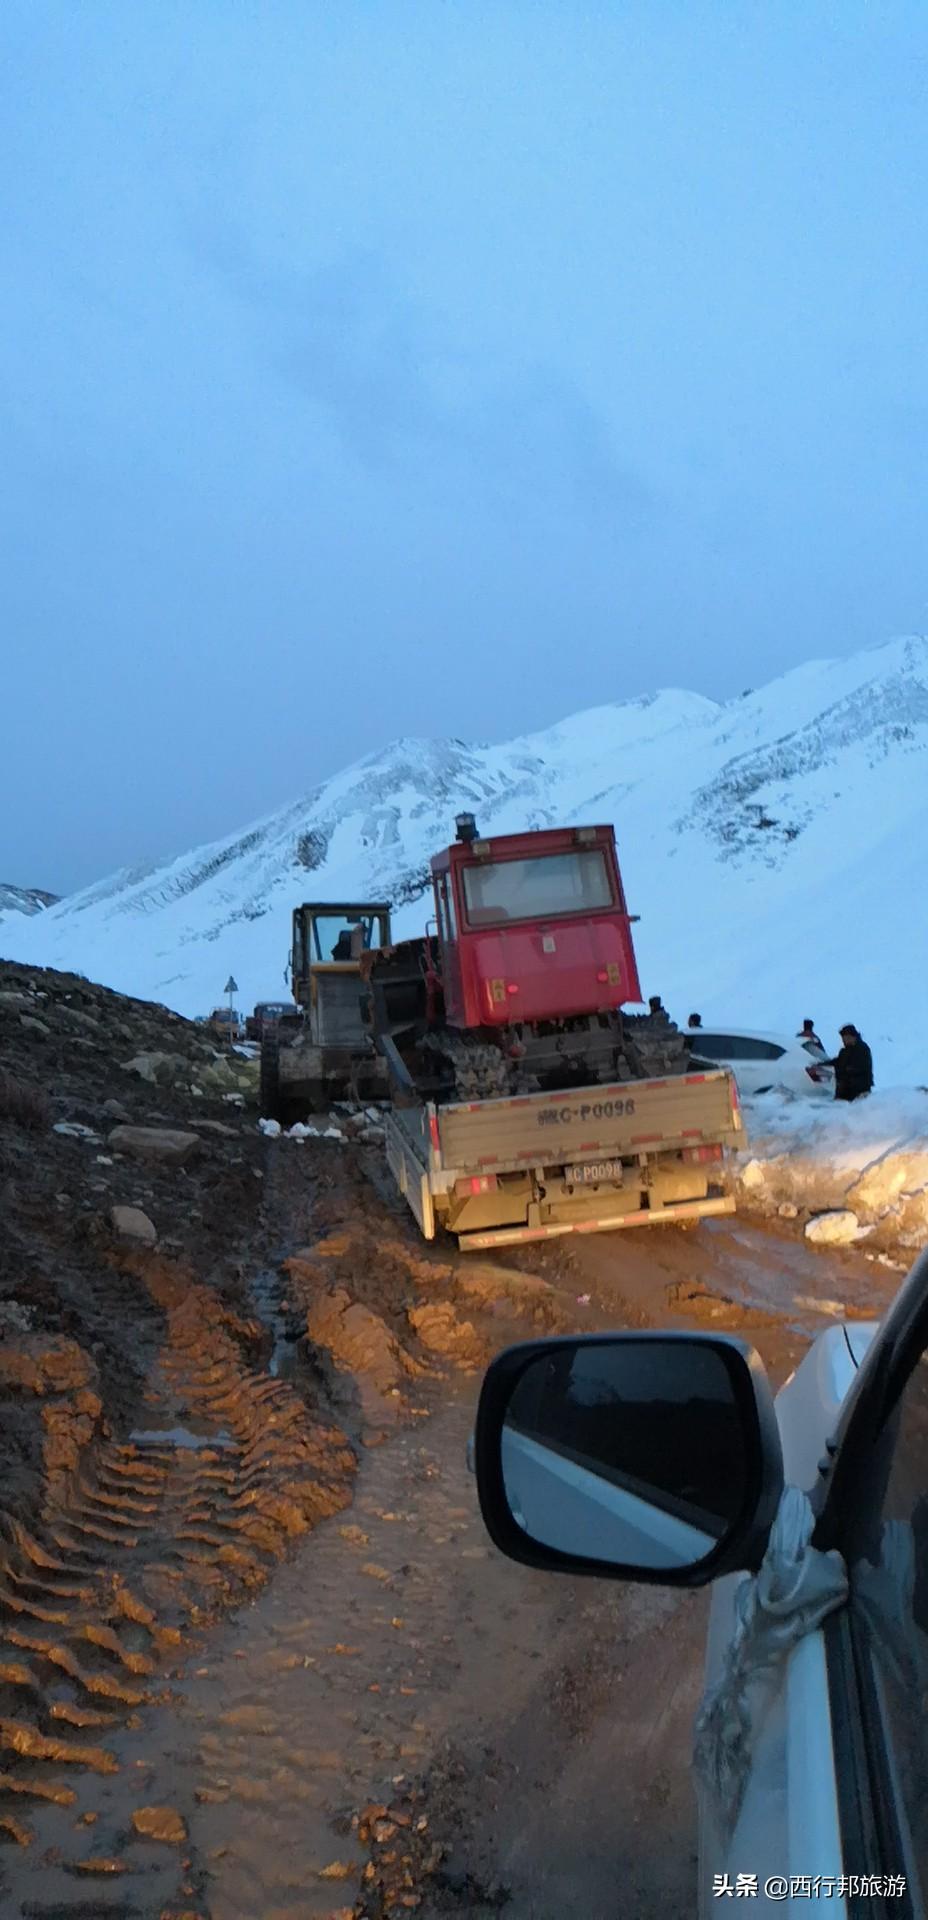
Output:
290,900,390,1046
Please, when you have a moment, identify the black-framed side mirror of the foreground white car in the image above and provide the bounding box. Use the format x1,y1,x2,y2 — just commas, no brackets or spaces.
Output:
473,1332,784,1586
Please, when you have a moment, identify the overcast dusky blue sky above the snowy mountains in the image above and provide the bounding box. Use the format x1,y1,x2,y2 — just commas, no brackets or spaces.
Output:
0,0,928,889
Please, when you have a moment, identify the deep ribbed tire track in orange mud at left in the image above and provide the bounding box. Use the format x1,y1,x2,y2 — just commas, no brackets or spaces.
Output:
0,1254,355,1920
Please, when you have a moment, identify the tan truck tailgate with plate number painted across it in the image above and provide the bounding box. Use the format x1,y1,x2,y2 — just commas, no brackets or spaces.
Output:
438,1071,742,1171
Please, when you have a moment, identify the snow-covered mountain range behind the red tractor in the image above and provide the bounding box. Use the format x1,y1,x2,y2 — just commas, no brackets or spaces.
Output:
0,637,928,1085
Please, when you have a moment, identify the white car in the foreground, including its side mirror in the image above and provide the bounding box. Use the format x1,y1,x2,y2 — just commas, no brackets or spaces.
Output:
473,1254,928,1920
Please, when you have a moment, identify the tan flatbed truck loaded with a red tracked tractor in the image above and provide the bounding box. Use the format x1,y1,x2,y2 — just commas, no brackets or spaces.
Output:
361,814,742,1248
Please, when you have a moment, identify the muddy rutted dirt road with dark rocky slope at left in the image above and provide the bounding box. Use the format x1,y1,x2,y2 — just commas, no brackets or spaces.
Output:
0,977,897,1920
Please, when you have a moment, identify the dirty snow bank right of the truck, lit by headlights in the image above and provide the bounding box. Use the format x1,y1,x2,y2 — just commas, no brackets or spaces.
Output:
738,1087,928,1250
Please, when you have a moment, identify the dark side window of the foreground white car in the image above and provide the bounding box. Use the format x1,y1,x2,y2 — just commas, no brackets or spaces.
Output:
845,1354,928,1912
